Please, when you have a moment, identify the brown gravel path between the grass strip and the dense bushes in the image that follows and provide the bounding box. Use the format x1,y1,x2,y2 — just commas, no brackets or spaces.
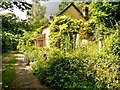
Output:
8,53,51,90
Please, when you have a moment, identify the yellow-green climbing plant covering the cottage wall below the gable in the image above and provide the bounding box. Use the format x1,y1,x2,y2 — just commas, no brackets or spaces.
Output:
50,16,82,50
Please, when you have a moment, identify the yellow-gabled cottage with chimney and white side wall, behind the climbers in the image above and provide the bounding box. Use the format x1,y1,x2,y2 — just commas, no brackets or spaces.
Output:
35,3,88,47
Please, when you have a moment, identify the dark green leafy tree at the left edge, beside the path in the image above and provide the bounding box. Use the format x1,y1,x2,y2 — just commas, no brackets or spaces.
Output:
0,13,29,53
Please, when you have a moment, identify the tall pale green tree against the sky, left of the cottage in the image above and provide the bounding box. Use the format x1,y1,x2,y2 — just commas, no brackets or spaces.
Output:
27,2,48,30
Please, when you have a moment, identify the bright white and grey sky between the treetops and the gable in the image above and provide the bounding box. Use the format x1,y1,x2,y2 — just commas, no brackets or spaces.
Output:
0,0,60,20
